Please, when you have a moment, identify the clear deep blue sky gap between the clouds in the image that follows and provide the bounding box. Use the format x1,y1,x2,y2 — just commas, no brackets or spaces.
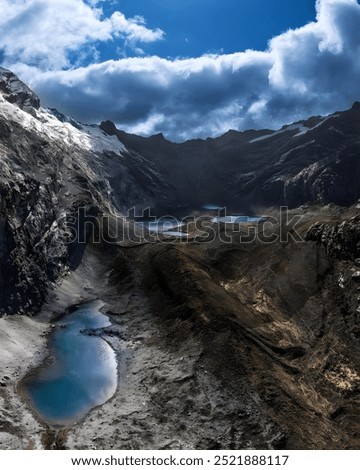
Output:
100,0,315,59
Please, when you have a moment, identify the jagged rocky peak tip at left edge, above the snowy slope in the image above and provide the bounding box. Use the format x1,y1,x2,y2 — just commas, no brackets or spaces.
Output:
0,67,40,111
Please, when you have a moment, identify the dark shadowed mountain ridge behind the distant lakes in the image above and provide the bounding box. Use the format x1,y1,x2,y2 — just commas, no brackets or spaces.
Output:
101,103,360,211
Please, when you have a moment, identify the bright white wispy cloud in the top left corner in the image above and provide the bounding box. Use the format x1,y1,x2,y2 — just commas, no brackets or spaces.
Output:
0,0,164,70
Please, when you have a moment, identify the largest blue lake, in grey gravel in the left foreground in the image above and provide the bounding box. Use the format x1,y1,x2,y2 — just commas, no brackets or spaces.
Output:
24,301,117,427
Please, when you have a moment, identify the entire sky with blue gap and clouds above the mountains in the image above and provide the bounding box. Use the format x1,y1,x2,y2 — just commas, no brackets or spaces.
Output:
0,0,360,141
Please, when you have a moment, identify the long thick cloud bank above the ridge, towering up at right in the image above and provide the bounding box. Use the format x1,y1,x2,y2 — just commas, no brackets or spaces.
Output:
0,0,360,140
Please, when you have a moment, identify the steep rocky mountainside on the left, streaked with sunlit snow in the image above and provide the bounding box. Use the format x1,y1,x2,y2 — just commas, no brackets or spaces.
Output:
0,69,167,314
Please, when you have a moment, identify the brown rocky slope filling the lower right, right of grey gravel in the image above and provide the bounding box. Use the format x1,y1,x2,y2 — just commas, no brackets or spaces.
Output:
131,208,360,449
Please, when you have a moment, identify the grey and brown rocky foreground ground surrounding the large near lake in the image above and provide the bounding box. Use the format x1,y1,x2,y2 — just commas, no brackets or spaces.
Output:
0,207,360,449
